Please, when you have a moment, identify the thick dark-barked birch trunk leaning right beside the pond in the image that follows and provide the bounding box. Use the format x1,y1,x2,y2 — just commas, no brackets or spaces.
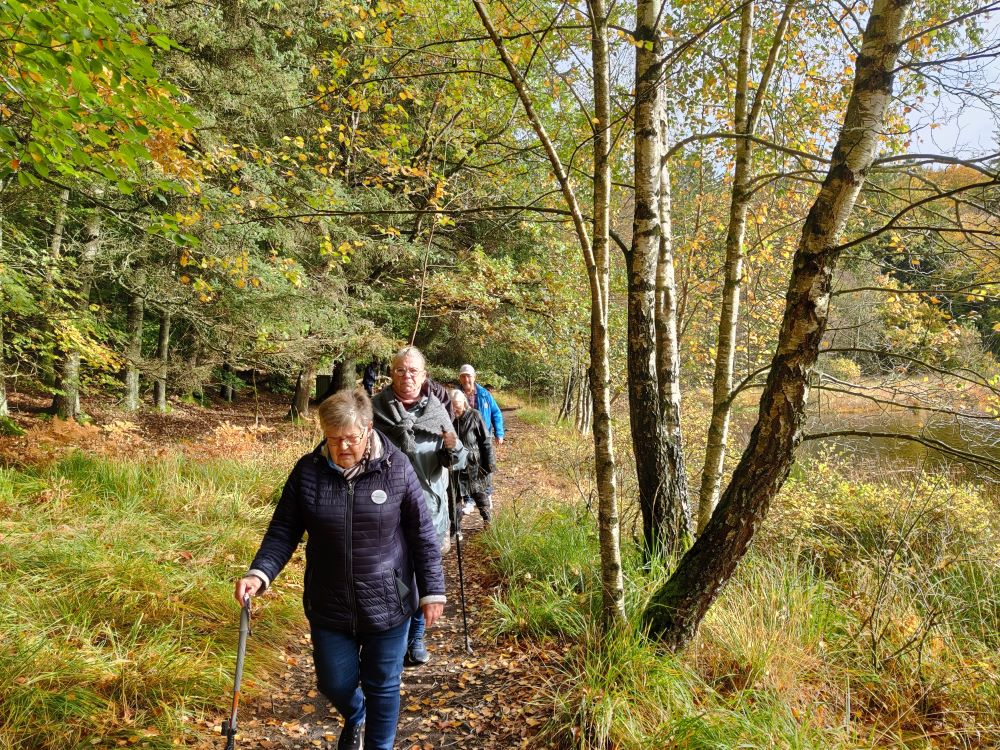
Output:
644,0,912,650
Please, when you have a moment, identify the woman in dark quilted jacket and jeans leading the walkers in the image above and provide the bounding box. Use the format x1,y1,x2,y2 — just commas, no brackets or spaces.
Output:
234,389,445,750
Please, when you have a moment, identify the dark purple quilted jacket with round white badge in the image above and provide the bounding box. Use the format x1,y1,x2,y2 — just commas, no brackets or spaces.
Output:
250,433,445,633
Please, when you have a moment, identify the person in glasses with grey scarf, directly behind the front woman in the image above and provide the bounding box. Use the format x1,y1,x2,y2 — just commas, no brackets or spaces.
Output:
372,346,468,666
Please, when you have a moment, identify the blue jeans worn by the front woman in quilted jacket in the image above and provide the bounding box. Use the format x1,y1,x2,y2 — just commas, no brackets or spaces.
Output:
311,619,410,750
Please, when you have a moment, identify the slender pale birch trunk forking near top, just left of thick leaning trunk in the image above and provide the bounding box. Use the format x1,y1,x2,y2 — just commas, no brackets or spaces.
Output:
698,0,795,534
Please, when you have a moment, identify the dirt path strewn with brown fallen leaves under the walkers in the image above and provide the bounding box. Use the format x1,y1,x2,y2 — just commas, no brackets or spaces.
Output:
199,414,558,750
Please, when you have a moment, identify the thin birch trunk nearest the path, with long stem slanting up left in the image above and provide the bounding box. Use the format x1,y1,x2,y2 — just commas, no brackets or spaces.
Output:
472,0,625,627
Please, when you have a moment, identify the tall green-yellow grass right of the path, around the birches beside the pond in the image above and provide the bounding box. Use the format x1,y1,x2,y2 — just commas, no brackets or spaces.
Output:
478,418,1000,750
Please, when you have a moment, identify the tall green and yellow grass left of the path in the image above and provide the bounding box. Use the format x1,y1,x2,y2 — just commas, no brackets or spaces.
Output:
0,453,301,750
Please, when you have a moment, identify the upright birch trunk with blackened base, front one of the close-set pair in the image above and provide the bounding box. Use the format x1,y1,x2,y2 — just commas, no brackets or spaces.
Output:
627,0,688,556
